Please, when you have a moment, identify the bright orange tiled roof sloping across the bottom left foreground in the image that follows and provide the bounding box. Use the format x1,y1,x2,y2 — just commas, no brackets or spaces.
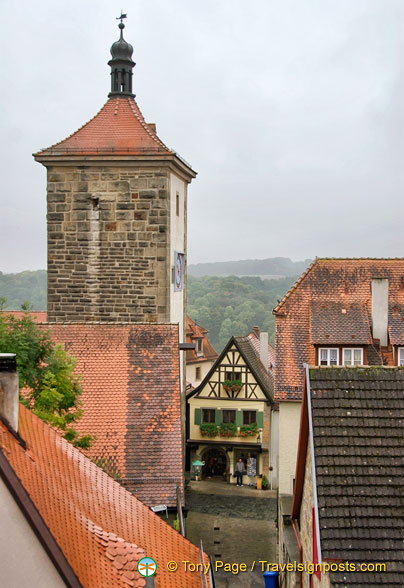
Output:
0,406,209,588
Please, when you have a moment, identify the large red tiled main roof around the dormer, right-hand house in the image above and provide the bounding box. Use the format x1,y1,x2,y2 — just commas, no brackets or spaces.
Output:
274,258,404,401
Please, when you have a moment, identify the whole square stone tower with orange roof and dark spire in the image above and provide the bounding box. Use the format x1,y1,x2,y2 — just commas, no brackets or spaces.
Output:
34,20,196,340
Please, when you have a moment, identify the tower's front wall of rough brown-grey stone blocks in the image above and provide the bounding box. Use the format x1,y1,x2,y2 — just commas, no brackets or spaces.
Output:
47,162,170,323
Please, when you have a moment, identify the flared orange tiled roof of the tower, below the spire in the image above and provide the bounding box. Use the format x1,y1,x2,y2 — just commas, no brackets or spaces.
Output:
35,97,174,158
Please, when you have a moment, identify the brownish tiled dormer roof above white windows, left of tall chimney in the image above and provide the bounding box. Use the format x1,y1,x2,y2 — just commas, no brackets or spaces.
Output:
310,301,372,345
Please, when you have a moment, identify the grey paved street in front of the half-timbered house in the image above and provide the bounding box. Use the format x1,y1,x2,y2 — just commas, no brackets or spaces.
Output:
186,480,277,588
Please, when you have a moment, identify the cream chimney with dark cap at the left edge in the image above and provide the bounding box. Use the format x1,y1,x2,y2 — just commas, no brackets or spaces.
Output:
0,353,19,433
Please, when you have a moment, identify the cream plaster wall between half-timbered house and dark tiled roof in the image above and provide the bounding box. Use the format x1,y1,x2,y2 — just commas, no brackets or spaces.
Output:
279,402,302,494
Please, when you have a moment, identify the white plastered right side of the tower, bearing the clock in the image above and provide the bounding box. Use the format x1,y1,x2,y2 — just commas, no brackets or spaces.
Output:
170,174,187,343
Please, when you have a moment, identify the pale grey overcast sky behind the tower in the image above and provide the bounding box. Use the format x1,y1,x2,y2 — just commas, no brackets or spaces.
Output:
0,0,404,272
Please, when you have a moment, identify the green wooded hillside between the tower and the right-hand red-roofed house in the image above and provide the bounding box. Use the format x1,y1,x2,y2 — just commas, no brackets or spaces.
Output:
187,276,297,352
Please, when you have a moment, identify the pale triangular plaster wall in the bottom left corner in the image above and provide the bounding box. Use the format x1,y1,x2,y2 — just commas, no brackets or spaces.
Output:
0,479,66,588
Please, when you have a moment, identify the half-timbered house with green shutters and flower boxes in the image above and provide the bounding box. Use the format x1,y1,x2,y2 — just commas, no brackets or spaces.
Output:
187,328,273,484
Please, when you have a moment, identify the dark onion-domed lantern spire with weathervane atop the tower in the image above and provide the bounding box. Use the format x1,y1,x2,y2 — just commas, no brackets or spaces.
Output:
108,12,136,98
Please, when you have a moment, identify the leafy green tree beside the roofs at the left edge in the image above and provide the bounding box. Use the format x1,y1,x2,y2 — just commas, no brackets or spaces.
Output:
0,303,92,449
